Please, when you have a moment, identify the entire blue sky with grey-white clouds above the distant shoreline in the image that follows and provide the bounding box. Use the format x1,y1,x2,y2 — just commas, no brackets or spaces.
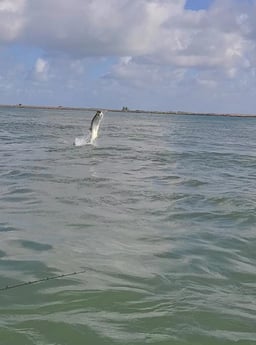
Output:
0,0,256,114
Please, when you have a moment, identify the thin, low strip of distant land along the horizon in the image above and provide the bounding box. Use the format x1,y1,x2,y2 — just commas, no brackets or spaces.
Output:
0,104,256,117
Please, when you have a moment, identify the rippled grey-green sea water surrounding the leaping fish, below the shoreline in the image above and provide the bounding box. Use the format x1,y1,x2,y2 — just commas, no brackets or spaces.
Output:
0,108,256,345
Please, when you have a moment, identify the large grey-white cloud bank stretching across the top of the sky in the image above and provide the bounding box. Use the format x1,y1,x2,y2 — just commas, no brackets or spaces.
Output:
0,0,252,74
